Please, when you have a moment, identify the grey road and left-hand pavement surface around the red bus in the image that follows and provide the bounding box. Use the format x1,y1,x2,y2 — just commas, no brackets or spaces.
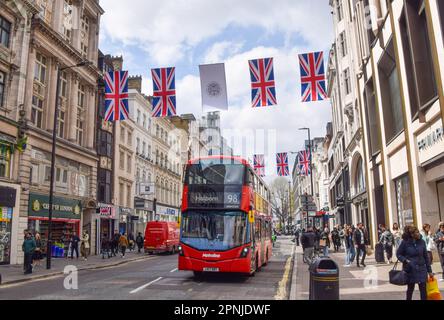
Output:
0,237,294,301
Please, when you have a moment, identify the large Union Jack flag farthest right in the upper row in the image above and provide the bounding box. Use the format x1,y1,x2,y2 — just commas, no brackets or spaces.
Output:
299,52,328,102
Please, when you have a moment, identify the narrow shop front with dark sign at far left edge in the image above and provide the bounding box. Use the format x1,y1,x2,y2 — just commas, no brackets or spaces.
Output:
0,186,17,265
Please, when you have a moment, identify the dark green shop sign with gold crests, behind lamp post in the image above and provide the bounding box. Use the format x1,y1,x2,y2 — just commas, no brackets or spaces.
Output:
29,193,82,220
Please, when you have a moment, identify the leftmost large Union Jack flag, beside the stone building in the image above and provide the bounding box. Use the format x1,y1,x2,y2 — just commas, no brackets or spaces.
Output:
105,71,129,121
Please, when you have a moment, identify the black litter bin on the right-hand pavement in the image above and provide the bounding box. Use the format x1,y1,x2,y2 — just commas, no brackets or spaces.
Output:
309,258,339,300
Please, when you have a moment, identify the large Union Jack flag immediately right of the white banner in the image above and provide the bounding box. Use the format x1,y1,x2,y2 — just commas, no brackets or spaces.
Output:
249,58,277,108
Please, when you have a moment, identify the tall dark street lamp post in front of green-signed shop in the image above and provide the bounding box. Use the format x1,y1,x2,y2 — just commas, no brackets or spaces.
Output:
46,61,92,270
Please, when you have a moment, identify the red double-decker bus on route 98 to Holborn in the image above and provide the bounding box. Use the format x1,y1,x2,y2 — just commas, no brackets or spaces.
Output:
179,156,273,276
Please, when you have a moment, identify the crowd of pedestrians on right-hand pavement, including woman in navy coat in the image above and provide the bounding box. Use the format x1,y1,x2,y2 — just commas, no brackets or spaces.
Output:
294,222,444,300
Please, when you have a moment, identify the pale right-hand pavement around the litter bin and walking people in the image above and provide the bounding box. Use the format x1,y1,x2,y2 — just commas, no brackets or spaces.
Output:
290,247,444,300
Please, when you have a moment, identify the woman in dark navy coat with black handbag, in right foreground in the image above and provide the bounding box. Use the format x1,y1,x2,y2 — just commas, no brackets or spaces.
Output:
397,226,434,300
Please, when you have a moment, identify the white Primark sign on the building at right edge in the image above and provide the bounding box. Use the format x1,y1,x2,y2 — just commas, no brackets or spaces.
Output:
417,120,444,164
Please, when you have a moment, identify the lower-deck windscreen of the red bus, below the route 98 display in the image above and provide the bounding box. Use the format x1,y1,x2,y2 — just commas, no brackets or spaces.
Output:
181,211,249,251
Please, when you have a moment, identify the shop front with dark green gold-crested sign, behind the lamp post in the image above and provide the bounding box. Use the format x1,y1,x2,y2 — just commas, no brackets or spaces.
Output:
28,193,82,253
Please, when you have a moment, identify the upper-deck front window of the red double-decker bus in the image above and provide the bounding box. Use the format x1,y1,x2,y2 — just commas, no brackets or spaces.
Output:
186,159,245,185
